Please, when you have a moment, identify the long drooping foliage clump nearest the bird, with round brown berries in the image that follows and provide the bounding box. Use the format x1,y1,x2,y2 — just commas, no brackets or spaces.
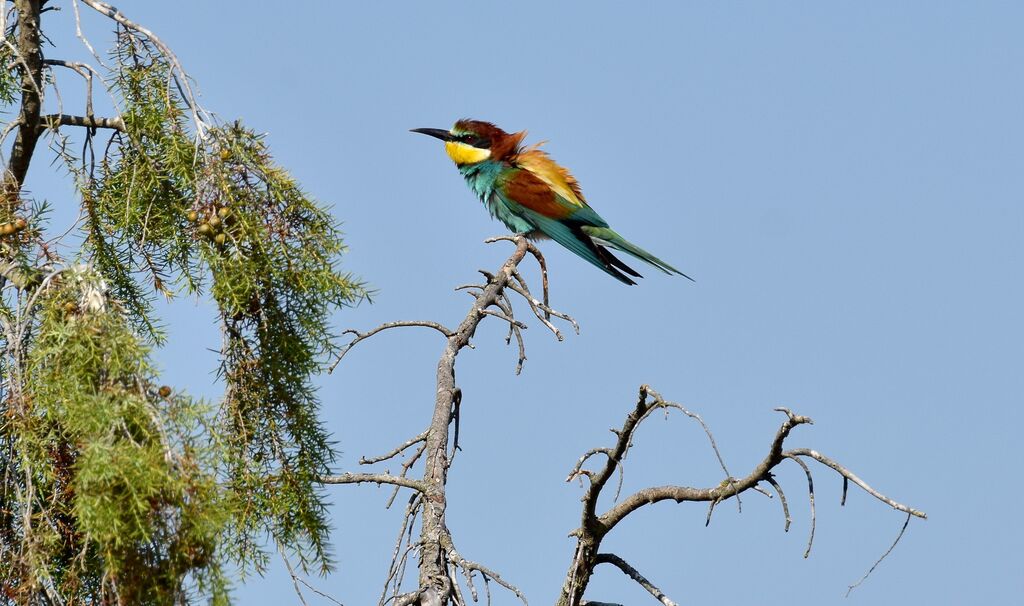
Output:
196,124,364,571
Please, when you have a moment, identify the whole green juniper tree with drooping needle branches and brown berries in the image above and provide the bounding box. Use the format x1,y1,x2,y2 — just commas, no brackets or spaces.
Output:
0,0,366,604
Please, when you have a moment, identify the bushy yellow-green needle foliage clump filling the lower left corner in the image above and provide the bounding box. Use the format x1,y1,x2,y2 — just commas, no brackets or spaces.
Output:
0,267,227,604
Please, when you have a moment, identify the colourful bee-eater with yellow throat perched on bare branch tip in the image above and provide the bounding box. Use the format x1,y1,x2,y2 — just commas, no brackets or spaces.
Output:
413,120,692,285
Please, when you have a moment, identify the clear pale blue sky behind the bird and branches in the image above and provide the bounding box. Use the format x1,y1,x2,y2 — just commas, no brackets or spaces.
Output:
19,0,1024,605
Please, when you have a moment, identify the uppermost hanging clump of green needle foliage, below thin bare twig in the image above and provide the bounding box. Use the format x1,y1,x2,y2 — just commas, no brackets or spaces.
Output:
83,36,204,337
